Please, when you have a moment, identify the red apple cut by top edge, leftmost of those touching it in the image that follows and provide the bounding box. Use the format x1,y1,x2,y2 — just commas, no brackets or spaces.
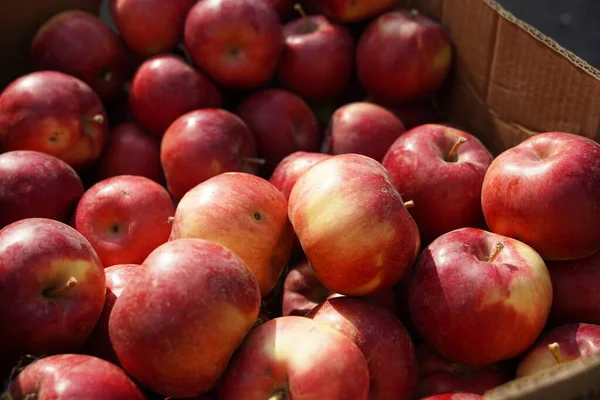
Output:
109,0,197,57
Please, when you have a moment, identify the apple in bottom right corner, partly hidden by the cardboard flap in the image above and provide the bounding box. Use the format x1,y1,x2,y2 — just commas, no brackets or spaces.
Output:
517,323,600,378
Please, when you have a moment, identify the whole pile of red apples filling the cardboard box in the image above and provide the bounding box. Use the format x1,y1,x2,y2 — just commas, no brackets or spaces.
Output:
0,0,600,400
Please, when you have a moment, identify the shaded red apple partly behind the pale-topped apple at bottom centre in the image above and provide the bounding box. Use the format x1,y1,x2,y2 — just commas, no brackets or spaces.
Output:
307,297,419,400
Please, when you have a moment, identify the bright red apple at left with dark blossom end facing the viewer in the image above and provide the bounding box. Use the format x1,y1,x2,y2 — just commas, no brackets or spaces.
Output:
75,175,175,267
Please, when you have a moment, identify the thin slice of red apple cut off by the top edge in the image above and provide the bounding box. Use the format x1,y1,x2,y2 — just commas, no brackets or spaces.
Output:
312,0,398,22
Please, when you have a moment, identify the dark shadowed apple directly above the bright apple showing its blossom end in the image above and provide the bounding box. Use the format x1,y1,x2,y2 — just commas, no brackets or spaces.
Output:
96,123,165,184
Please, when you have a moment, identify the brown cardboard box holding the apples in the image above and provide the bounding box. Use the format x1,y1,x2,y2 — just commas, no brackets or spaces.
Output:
0,0,600,400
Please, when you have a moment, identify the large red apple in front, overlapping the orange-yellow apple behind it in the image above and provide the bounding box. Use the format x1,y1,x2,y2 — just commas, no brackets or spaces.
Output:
108,239,260,397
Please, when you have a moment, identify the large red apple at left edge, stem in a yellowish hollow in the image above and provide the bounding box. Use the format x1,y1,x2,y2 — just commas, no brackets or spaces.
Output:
0,218,106,358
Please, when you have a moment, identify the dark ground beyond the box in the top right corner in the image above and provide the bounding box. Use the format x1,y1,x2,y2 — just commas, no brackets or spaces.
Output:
500,0,600,68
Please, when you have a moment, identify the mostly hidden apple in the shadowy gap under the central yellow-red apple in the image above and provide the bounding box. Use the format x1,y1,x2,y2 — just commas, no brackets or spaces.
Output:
281,260,398,317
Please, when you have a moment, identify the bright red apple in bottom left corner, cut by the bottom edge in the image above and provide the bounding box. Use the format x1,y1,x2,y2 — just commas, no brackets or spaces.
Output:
0,354,146,400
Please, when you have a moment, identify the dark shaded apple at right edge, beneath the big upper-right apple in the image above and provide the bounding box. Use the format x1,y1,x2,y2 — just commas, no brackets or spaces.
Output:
546,251,600,325
